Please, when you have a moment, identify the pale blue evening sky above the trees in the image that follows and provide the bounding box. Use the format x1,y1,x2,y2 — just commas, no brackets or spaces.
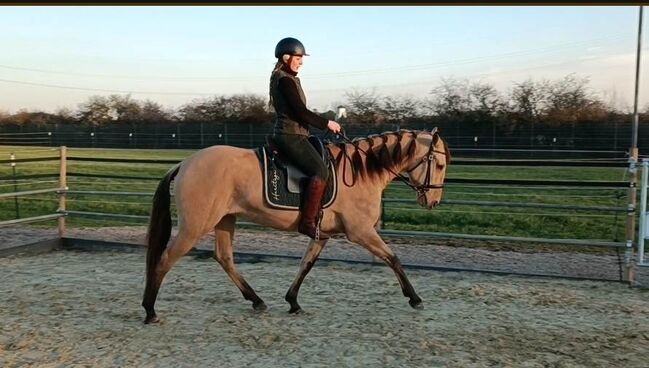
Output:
0,5,649,113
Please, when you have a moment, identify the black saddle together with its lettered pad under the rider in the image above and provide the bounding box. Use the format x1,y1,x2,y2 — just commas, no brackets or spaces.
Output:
257,135,338,210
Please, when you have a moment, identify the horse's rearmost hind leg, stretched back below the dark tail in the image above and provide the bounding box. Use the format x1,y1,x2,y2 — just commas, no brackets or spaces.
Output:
142,229,198,324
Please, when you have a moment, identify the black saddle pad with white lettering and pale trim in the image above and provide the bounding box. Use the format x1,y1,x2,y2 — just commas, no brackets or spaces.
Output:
257,146,338,210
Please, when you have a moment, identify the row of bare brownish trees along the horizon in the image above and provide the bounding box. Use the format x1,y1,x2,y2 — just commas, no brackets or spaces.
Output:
0,74,649,132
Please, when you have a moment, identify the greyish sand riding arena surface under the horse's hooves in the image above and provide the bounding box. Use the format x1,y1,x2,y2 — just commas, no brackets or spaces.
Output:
0,251,649,367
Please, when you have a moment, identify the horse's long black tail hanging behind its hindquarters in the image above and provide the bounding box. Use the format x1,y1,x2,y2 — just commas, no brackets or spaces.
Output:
146,164,180,280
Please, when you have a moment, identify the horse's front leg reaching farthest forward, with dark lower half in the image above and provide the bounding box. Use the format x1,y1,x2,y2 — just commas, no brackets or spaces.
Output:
346,228,424,309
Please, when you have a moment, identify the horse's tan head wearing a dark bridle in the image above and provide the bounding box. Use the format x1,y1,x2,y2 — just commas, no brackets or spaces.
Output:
406,128,451,209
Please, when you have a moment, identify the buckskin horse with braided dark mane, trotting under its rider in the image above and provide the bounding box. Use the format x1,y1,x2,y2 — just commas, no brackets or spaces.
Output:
142,128,451,324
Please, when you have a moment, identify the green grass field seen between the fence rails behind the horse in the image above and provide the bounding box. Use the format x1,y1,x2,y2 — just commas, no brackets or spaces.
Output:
0,146,627,247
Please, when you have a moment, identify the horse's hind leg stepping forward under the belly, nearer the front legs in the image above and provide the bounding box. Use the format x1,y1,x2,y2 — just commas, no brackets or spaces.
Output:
214,215,266,311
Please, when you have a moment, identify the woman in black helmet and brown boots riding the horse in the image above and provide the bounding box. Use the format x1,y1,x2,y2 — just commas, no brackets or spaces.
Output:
268,37,340,239
